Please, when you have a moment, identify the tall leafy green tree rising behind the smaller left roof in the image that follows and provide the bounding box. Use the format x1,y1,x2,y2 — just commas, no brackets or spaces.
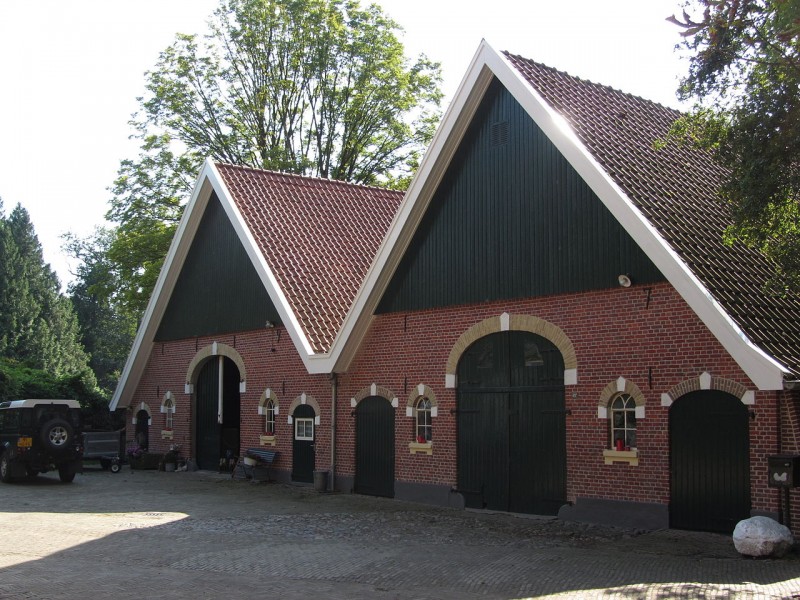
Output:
107,0,441,314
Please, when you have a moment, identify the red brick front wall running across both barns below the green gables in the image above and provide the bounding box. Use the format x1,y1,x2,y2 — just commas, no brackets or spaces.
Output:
128,284,784,522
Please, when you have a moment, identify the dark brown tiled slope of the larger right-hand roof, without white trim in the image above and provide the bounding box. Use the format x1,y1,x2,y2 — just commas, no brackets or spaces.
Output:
504,52,800,376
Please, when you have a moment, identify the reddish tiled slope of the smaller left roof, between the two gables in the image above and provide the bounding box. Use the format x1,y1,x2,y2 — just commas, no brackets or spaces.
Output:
216,164,403,354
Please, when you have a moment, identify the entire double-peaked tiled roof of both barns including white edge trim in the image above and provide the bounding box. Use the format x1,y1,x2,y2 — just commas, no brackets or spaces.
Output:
112,42,800,408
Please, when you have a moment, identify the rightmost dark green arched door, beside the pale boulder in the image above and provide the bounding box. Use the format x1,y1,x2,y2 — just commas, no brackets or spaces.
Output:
669,390,750,533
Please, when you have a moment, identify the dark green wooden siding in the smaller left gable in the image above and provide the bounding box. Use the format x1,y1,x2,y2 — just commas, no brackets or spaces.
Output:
155,195,280,341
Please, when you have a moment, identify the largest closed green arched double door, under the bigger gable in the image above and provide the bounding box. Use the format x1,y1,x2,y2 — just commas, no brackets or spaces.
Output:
457,331,566,514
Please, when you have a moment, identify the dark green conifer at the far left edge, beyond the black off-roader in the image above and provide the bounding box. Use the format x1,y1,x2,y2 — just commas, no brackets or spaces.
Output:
0,205,88,376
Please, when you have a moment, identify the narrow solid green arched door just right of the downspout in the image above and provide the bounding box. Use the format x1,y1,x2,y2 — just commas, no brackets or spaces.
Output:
355,396,394,498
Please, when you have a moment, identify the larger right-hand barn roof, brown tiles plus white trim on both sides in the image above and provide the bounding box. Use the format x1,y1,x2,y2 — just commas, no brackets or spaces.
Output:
331,42,800,390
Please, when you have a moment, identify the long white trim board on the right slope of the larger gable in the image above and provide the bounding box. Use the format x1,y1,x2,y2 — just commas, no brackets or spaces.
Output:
488,53,788,390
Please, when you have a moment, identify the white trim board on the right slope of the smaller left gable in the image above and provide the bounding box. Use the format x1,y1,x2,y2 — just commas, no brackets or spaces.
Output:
209,161,314,366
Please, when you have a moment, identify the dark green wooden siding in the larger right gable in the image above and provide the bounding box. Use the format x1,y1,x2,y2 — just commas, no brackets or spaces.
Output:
376,80,664,313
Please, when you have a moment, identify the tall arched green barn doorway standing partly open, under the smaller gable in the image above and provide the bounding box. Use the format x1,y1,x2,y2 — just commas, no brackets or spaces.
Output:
195,357,240,469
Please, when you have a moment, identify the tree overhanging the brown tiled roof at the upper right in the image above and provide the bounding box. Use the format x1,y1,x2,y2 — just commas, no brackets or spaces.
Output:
670,0,800,291
